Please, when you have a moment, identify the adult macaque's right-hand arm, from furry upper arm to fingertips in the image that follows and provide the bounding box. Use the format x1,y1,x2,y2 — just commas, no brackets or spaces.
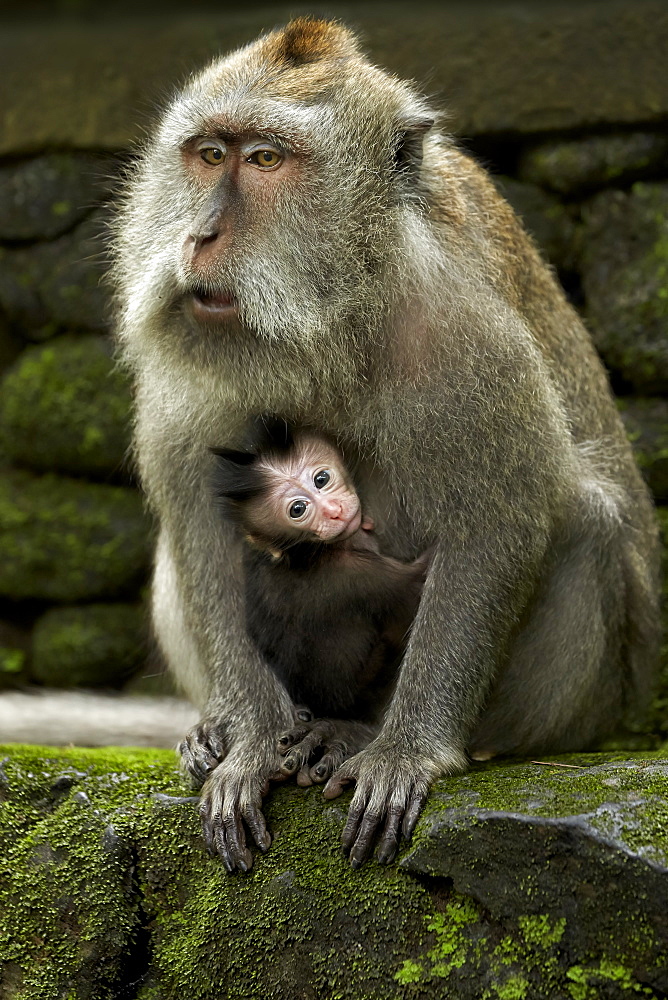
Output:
324,345,577,867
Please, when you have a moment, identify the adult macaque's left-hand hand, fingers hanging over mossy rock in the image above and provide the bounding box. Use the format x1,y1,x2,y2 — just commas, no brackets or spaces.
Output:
199,740,276,873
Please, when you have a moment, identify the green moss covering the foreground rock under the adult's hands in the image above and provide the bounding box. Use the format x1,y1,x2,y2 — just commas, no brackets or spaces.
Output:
0,747,664,1000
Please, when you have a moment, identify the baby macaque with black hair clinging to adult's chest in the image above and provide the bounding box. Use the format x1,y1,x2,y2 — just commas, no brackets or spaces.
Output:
213,418,429,784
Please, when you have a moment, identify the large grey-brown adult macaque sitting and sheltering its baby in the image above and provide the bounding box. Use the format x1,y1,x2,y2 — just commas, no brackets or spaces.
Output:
116,18,658,871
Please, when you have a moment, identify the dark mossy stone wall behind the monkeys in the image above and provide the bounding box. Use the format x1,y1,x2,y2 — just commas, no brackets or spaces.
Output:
0,0,668,737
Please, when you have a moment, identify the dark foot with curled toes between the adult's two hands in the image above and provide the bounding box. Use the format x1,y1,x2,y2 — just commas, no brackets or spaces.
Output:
278,719,374,788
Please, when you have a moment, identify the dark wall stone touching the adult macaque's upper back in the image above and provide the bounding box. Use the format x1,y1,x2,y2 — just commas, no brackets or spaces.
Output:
495,177,577,271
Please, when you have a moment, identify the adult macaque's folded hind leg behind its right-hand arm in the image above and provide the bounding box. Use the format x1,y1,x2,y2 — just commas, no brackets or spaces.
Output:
469,522,657,760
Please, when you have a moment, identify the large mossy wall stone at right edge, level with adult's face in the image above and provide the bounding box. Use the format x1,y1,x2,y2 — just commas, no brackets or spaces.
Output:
582,183,668,392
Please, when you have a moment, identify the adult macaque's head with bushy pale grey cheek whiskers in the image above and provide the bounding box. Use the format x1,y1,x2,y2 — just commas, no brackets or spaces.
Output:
117,23,436,362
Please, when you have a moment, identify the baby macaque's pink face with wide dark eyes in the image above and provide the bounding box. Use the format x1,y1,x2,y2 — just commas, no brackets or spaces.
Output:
249,434,370,542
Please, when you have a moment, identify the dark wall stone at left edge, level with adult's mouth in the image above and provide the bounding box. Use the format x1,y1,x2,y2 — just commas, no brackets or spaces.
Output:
0,210,111,340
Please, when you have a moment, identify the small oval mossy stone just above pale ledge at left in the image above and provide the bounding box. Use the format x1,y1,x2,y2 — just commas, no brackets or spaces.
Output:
31,604,147,687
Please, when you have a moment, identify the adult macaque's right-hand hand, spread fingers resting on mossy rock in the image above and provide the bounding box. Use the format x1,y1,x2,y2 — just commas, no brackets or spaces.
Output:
323,740,452,868
